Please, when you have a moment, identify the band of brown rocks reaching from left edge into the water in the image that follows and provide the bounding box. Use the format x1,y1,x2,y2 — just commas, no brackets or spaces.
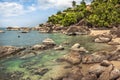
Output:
0,38,64,58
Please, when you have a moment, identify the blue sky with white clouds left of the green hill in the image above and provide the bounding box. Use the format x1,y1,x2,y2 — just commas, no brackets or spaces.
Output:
0,0,89,27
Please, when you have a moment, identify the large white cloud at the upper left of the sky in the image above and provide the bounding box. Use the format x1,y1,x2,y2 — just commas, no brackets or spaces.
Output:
0,2,36,17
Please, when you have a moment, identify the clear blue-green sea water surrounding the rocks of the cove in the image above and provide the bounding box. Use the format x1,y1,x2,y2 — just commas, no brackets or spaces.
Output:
0,31,110,80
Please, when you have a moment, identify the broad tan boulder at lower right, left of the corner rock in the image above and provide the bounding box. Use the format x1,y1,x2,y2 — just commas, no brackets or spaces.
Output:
88,65,106,76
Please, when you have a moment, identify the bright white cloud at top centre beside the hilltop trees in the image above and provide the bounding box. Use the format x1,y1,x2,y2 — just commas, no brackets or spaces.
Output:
38,0,81,9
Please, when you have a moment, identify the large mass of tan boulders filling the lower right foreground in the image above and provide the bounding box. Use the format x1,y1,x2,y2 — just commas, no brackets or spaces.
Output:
41,43,120,80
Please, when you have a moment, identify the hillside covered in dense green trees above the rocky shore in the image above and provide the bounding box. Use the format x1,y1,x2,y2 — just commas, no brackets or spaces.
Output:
48,0,120,27
